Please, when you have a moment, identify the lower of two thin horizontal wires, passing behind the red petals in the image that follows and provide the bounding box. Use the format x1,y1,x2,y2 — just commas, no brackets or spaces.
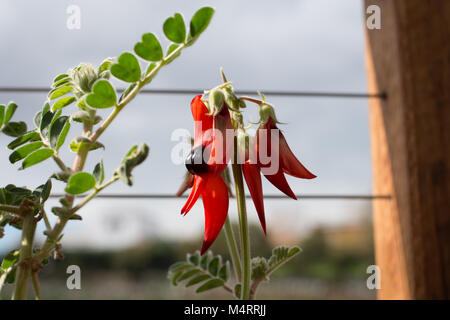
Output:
50,193,392,200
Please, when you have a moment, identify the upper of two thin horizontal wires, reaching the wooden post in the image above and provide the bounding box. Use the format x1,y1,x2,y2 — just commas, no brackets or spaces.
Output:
0,87,386,99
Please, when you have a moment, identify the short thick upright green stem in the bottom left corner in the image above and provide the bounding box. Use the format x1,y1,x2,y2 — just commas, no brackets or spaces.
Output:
12,210,36,300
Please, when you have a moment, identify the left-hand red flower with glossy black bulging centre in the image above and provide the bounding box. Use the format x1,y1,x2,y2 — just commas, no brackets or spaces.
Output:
181,95,232,254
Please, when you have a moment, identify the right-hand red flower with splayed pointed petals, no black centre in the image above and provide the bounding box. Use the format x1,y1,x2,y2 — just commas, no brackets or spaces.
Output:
242,104,316,233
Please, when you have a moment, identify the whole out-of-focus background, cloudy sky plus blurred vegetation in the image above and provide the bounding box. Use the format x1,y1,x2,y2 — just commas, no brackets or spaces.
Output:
0,0,375,299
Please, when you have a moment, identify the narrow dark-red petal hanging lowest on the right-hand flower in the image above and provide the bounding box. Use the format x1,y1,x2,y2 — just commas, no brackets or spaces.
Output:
242,162,266,234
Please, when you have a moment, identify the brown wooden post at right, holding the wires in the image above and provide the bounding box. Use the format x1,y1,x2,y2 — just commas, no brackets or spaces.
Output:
365,0,450,299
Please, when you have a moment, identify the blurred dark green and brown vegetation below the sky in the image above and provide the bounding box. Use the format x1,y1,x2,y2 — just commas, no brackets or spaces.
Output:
1,222,375,299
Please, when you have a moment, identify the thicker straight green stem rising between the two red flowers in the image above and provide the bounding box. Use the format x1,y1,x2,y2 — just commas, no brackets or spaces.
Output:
232,158,251,300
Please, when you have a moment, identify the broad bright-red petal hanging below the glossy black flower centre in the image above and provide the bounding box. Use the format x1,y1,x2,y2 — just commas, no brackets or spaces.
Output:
201,175,228,254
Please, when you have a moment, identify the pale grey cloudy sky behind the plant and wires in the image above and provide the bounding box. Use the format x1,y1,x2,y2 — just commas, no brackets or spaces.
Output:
0,0,372,252
